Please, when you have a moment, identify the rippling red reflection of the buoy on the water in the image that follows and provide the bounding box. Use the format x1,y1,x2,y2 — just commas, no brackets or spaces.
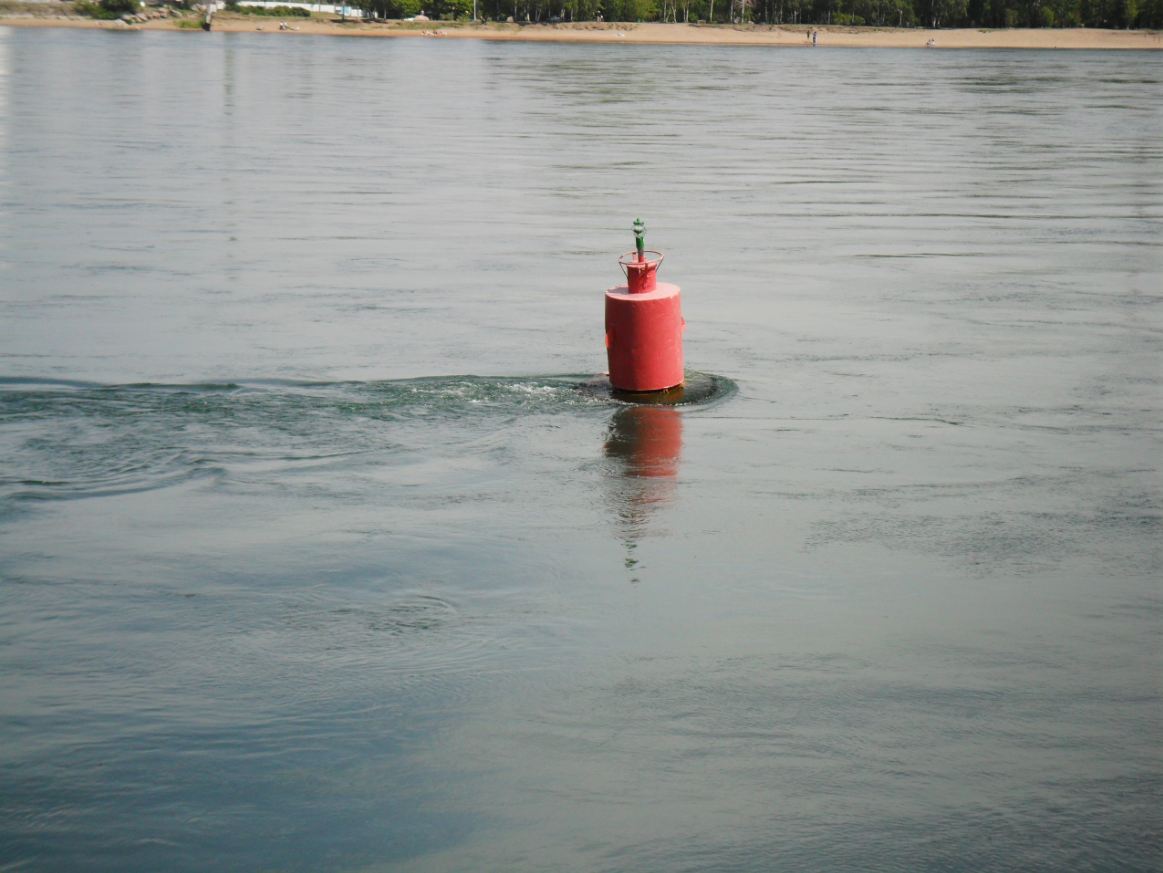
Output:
605,406,683,582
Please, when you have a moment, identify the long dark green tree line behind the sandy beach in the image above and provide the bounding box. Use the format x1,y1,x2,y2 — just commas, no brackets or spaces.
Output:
357,0,1163,28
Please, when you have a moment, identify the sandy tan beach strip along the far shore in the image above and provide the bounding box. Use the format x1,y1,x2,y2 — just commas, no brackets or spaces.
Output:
0,13,1163,50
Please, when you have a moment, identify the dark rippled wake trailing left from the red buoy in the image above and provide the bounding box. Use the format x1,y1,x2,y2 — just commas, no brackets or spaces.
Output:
0,374,734,501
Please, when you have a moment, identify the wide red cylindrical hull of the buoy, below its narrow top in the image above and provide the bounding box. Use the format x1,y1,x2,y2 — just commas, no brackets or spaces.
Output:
606,282,686,391
